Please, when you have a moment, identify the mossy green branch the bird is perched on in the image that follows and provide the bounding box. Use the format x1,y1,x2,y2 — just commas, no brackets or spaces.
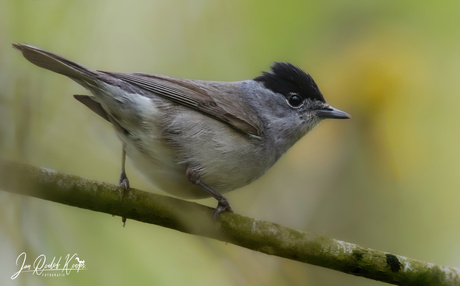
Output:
0,161,460,286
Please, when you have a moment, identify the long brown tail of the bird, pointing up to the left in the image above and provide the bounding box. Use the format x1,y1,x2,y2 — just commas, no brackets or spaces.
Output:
13,44,96,83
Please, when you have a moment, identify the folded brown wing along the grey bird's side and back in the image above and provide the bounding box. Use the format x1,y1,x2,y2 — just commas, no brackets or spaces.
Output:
103,72,262,136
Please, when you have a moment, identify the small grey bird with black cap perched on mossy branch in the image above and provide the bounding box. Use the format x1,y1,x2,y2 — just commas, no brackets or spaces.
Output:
13,44,350,218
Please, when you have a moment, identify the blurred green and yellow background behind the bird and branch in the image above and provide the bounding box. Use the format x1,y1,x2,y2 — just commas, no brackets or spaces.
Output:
0,0,460,285
